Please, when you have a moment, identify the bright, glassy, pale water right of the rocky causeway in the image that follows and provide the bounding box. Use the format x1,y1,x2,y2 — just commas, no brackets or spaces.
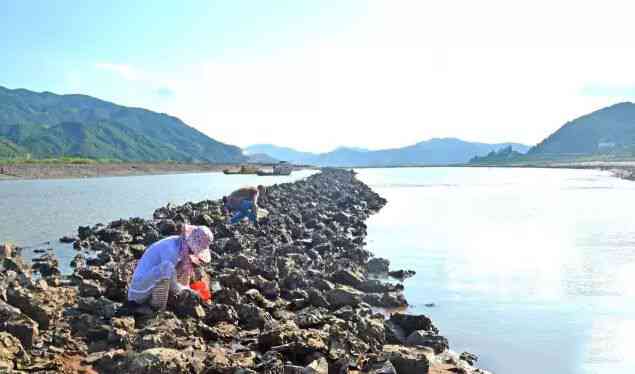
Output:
359,168,635,374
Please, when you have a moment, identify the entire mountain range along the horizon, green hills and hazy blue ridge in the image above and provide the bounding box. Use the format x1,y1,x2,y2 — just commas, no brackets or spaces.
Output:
0,86,635,167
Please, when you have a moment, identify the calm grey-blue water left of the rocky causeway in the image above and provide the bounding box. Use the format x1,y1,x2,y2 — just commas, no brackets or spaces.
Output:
0,170,314,272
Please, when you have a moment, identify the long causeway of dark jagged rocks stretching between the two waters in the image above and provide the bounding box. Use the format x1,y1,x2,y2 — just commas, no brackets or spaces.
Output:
0,169,492,374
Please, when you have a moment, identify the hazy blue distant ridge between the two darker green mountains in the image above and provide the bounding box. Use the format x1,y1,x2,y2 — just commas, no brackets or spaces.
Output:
245,138,529,167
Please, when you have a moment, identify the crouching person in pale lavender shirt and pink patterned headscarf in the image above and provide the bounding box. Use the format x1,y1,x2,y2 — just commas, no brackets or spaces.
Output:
128,225,214,310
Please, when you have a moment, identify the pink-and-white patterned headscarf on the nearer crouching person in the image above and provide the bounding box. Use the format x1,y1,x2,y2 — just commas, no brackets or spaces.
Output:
179,225,214,276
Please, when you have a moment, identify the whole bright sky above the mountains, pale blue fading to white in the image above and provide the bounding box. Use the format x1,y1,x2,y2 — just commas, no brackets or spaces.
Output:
0,0,635,152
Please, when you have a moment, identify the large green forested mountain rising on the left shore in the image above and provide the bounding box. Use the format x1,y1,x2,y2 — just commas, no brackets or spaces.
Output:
0,86,245,162
